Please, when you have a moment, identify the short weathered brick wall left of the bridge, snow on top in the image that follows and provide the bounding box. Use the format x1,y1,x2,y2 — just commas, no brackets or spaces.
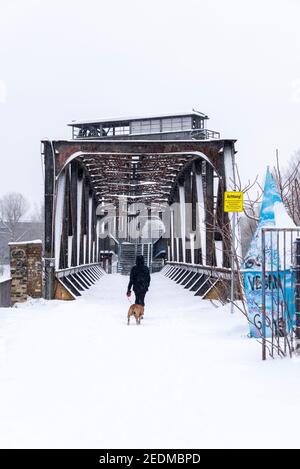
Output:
9,240,42,304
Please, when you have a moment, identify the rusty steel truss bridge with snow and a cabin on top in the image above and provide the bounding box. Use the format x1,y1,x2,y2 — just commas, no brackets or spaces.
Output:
42,111,235,299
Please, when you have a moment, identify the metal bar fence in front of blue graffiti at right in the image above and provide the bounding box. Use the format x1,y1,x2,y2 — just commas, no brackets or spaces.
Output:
257,228,300,360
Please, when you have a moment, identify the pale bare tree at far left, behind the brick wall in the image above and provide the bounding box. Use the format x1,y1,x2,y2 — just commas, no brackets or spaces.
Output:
0,192,29,241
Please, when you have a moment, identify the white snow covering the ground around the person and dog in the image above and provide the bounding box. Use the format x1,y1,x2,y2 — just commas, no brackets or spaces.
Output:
0,274,300,448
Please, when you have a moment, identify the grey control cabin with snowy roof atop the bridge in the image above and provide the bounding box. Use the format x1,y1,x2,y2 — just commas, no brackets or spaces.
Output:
69,111,220,140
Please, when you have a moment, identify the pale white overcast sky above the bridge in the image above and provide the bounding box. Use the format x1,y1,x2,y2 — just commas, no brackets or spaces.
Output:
0,0,300,210
